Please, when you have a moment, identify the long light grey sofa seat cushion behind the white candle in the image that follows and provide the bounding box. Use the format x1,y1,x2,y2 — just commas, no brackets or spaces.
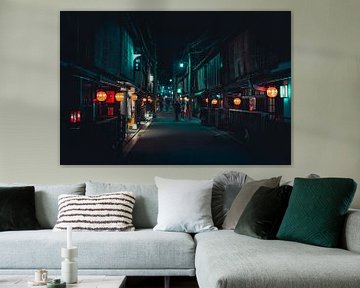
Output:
0,229,195,270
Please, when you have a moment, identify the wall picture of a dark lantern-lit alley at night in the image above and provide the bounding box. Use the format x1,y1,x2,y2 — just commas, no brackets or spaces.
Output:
60,11,293,165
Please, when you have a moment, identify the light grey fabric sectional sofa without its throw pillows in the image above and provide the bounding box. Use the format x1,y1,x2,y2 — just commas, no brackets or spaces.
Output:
0,182,360,288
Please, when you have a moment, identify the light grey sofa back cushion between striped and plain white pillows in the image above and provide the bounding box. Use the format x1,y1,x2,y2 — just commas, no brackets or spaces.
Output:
86,181,158,229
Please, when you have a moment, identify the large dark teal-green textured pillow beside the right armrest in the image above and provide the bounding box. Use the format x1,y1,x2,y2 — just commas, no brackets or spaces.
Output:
277,178,356,247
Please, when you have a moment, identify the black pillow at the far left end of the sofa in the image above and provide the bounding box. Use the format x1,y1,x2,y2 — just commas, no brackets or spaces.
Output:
0,186,40,231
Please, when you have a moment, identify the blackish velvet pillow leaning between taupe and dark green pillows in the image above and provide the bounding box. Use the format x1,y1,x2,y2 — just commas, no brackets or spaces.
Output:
235,185,292,239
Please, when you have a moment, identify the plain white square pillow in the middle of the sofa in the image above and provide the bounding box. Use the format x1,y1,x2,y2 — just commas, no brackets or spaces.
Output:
154,177,217,233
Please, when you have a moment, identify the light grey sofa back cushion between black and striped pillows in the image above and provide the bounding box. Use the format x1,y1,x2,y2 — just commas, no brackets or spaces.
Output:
0,183,85,229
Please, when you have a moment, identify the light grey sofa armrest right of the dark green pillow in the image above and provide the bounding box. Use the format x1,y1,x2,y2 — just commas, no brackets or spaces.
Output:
343,210,360,253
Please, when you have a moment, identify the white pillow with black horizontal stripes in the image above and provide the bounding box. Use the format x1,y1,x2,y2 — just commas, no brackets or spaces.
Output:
54,191,135,231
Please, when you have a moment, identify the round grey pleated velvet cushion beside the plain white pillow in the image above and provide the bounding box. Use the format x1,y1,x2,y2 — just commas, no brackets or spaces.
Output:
211,171,252,228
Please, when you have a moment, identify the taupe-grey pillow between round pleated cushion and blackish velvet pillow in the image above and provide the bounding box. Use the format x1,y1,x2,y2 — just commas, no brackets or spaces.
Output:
222,176,281,230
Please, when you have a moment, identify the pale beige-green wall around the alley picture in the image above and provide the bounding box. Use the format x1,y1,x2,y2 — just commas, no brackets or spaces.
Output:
0,0,360,207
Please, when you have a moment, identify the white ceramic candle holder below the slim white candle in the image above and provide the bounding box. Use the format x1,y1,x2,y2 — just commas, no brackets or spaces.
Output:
61,247,78,284
